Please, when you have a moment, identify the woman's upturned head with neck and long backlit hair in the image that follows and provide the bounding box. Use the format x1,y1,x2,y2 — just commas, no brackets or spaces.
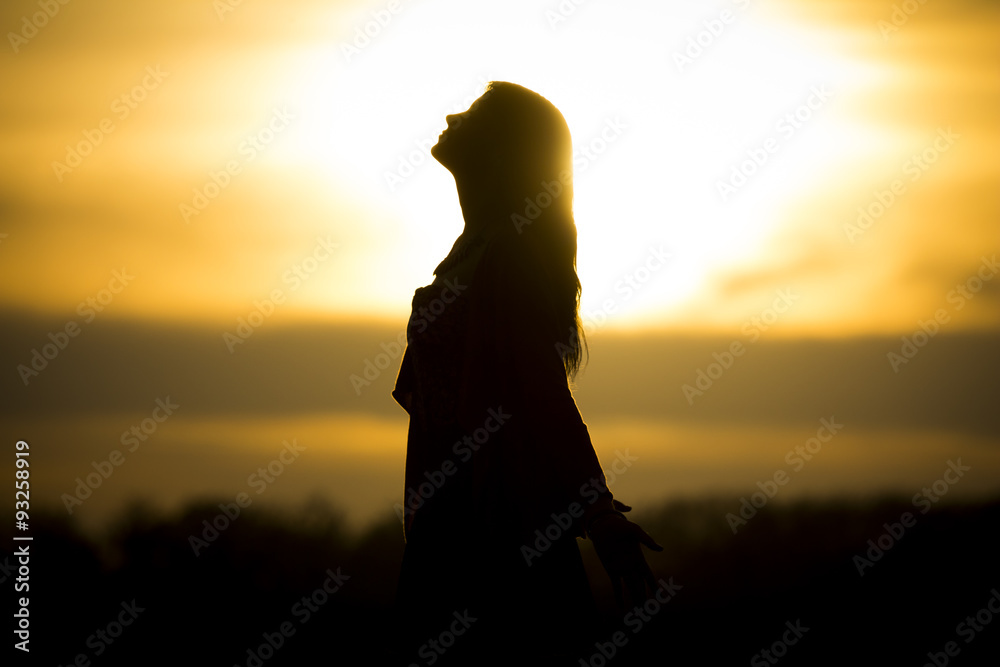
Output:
431,81,584,376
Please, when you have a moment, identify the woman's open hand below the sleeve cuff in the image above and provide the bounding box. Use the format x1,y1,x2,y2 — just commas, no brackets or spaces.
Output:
588,501,663,609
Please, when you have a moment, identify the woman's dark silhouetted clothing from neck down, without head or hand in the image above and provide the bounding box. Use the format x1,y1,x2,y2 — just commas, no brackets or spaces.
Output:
392,228,611,664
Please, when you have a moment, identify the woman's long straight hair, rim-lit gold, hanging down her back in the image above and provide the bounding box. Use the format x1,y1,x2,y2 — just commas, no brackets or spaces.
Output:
480,81,586,379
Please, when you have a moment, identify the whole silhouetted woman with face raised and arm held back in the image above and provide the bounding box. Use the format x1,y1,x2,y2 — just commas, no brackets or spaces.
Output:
392,82,661,665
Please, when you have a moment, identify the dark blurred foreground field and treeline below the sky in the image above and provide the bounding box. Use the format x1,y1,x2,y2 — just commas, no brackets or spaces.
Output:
0,499,1000,667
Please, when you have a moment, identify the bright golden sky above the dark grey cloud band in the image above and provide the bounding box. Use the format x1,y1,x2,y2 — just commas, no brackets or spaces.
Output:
0,0,1000,336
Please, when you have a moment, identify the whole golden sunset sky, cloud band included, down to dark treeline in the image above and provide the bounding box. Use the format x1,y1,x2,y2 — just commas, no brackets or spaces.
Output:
0,0,1000,523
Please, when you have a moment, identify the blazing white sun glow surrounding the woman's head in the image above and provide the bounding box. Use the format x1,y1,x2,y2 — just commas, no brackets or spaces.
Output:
272,1,879,332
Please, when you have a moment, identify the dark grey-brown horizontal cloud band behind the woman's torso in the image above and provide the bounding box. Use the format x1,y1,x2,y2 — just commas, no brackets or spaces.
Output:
0,312,1000,437
